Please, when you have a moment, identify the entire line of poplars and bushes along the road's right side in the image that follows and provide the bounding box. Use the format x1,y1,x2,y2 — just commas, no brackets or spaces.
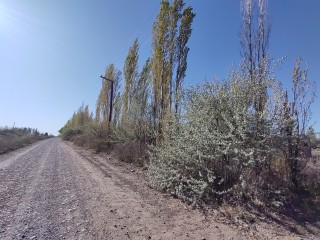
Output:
60,0,315,204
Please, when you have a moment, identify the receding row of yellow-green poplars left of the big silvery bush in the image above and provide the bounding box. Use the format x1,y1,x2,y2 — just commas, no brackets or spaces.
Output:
60,0,195,143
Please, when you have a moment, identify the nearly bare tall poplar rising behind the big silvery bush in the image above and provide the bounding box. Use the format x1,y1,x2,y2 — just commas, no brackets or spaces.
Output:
240,0,271,113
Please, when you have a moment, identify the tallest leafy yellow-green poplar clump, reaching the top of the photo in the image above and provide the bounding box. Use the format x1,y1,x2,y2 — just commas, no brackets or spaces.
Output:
151,0,195,134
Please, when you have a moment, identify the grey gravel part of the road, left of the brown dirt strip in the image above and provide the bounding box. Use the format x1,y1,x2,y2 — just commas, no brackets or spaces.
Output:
0,139,93,239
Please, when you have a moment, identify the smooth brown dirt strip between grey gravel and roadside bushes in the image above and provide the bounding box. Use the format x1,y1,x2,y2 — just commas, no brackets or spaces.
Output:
65,143,235,239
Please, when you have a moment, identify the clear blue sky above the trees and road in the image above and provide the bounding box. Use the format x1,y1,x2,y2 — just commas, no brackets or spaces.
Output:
0,0,320,134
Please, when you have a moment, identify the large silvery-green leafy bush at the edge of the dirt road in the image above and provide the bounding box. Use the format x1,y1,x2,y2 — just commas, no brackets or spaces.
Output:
149,70,280,203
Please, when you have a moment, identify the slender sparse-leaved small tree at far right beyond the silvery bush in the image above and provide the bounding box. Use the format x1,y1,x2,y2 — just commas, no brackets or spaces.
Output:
283,58,315,188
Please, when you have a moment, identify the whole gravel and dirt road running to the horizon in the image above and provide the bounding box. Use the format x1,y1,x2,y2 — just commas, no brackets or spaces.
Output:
0,138,316,239
